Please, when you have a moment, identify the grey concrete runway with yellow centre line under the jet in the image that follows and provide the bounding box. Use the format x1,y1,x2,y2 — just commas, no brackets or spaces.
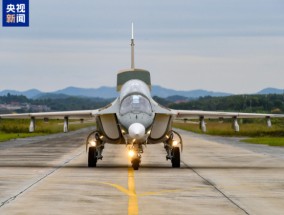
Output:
0,129,284,215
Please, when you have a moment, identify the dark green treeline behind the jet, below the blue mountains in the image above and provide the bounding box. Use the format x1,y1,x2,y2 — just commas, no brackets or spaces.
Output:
0,94,284,113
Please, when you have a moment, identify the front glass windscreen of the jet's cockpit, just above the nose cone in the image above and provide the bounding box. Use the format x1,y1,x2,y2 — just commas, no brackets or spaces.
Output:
120,94,152,115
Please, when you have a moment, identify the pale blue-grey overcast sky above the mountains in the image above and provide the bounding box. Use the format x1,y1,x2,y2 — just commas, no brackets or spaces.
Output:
0,0,284,93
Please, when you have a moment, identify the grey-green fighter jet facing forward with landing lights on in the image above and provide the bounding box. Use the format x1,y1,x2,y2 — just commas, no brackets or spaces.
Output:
0,25,284,170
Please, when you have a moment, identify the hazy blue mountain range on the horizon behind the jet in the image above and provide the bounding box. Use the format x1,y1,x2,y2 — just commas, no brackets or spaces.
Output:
0,85,284,99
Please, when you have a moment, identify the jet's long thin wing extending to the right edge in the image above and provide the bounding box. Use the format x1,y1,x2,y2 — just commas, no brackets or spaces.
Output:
172,110,284,119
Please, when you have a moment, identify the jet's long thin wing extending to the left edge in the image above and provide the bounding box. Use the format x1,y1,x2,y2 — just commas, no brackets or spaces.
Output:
0,110,98,119
